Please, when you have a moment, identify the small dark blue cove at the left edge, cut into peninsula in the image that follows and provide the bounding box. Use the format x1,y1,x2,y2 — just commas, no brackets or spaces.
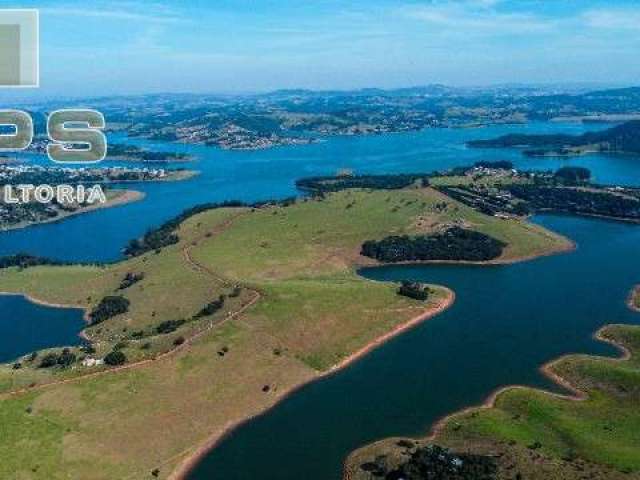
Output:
0,295,86,362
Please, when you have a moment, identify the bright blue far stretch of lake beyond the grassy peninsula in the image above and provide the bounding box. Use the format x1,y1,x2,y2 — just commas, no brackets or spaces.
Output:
0,123,640,262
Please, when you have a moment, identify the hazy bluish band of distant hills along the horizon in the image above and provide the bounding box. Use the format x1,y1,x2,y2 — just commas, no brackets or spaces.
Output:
31,84,640,151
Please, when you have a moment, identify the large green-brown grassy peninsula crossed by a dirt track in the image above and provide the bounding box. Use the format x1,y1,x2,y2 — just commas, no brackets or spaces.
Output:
0,189,568,480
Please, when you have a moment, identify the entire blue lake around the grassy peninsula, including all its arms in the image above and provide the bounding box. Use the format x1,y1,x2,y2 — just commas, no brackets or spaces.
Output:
0,123,640,474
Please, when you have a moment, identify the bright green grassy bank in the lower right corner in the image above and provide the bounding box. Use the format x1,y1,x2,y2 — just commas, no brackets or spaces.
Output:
349,326,640,480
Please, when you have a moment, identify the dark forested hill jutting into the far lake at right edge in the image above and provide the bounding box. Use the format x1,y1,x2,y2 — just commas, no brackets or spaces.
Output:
468,120,640,153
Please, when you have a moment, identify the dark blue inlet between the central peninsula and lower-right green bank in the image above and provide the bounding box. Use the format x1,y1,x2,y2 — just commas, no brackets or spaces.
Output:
188,215,640,480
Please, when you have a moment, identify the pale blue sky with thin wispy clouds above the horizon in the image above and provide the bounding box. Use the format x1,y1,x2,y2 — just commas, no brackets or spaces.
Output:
2,0,640,95
